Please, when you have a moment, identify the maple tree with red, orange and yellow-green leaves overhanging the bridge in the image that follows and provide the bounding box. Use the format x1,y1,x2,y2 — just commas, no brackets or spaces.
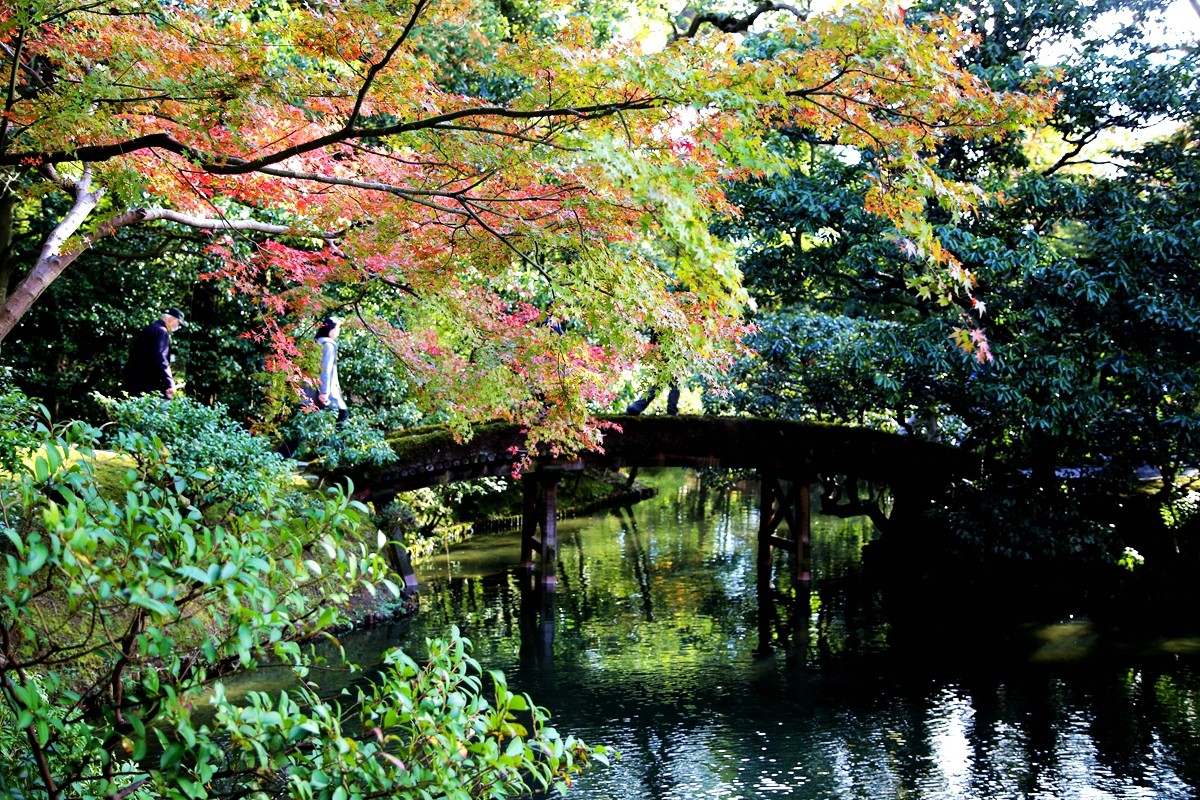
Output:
0,0,1048,446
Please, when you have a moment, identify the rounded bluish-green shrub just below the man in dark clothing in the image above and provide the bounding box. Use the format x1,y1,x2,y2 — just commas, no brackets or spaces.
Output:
98,395,292,510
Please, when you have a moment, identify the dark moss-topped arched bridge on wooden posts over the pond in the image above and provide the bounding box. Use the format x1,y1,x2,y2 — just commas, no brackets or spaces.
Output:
350,416,982,590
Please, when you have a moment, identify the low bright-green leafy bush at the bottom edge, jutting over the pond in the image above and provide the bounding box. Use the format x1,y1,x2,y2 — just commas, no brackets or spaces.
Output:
205,628,607,800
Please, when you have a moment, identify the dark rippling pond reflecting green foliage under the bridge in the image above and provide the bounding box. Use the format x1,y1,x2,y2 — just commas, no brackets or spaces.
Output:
344,470,1200,800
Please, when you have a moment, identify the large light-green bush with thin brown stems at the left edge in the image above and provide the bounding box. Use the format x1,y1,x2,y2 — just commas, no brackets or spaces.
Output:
0,417,384,798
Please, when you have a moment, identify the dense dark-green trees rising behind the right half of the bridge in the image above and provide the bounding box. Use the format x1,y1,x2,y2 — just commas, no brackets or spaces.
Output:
721,0,1200,557
